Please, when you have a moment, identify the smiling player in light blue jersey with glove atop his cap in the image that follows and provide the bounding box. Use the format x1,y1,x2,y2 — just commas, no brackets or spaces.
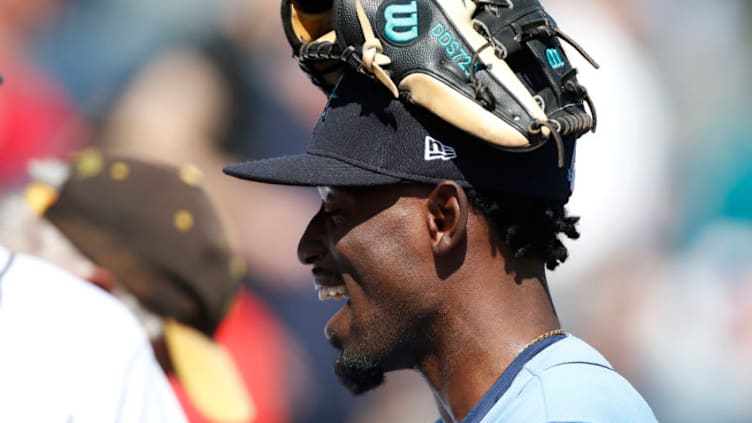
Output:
225,0,655,422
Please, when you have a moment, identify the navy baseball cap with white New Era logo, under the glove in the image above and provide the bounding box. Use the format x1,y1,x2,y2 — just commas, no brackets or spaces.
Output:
224,72,575,200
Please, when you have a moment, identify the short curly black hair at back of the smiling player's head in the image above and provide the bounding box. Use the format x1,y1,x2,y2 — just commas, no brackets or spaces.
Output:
466,189,580,270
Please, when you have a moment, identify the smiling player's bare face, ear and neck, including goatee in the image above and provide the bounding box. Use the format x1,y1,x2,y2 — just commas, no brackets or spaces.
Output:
298,181,559,422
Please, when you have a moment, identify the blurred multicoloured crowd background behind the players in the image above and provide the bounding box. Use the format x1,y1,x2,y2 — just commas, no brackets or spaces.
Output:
0,0,752,423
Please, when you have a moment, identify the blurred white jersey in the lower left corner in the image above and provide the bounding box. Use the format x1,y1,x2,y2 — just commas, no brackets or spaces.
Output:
0,246,185,423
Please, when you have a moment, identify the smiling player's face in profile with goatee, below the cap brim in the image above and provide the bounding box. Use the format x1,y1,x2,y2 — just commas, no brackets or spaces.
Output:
298,185,436,393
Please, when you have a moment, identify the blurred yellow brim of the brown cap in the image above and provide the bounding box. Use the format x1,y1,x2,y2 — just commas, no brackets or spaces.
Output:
164,319,256,422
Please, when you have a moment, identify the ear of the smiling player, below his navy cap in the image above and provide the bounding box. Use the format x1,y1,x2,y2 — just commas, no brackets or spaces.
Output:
428,181,469,255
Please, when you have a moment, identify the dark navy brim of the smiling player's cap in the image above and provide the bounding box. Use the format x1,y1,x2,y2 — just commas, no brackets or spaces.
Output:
224,153,402,186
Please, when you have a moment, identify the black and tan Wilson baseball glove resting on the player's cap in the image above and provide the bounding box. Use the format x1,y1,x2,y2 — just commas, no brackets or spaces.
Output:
282,0,598,167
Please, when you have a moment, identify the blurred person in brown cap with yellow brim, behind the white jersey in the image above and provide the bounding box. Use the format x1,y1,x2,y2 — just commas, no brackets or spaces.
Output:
29,150,287,422
